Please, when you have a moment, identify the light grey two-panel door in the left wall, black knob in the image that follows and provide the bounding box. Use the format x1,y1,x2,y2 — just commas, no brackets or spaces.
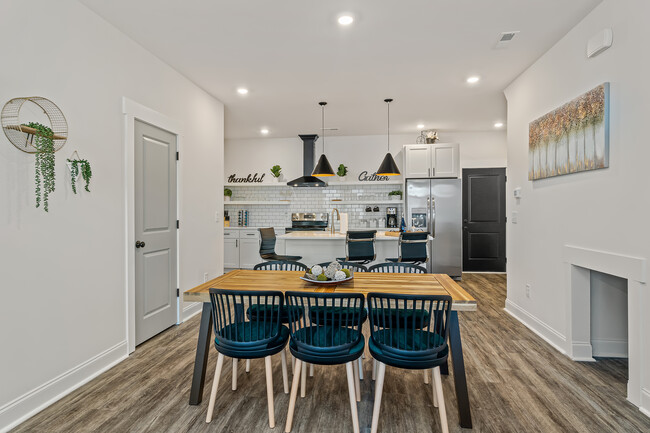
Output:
133,120,177,345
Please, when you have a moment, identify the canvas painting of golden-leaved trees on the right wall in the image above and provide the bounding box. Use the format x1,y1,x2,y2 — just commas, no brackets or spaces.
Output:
528,83,609,180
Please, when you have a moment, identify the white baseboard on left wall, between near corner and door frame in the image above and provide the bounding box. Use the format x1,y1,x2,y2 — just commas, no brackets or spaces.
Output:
0,341,128,433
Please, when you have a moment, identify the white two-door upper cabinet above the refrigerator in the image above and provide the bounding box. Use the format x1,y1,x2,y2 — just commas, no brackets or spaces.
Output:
404,143,460,179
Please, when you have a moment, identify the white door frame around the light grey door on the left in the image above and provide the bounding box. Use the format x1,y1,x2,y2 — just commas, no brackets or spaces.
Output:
122,97,184,354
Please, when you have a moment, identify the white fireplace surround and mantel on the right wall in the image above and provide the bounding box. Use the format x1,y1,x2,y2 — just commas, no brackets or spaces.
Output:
563,245,650,416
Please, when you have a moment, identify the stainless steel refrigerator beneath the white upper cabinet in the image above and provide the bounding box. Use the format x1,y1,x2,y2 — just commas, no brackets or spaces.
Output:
404,179,463,278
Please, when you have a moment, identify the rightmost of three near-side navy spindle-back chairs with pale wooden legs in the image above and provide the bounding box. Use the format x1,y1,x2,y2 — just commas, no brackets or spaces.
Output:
368,293,452,433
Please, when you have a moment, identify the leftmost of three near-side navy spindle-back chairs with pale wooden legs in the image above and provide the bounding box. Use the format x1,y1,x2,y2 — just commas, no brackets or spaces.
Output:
205,288,289,428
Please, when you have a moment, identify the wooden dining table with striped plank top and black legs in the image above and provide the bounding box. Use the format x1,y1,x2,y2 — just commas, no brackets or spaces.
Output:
183,269,477,428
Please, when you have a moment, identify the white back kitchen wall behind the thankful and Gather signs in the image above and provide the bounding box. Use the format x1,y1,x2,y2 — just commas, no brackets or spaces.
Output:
224,131,507,182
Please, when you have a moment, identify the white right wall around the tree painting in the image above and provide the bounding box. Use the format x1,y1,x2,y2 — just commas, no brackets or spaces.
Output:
505,0,650,410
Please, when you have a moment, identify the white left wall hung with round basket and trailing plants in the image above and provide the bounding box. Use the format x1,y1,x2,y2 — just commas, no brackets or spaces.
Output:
0,0,223,431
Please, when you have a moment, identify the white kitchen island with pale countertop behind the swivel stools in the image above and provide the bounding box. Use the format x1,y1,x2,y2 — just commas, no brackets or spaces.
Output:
276,229,433,266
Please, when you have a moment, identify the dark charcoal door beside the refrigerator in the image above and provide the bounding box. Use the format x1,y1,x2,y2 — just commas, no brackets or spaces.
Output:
463,168,506,272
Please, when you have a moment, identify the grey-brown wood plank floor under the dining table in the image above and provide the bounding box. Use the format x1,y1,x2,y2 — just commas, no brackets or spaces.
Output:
13,274,650,433
